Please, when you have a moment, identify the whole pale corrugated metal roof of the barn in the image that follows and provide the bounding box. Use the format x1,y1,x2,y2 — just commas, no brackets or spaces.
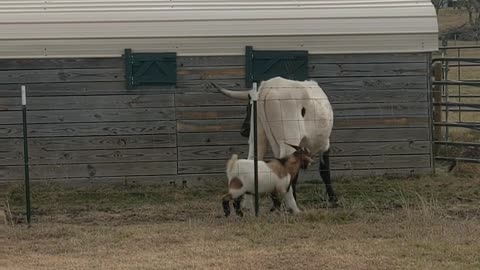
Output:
0,0,438,58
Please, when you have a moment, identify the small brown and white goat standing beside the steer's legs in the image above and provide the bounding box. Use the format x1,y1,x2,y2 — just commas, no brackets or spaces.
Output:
222,144,313,217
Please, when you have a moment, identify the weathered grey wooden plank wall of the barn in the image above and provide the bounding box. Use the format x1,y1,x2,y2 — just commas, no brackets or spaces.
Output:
0,54,432,187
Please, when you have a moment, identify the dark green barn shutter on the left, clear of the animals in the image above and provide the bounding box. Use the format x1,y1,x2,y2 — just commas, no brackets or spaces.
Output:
124,49,177,89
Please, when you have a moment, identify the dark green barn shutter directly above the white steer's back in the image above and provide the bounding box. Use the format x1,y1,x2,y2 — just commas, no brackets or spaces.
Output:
245,46,308,87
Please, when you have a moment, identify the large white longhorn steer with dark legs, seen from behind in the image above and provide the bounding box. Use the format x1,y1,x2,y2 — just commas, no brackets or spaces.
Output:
212,77,337,208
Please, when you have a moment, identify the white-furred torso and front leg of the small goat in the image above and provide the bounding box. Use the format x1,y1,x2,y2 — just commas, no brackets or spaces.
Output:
227,155,300,213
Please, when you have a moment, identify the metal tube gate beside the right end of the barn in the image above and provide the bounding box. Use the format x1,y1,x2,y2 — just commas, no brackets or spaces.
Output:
432,46,480,170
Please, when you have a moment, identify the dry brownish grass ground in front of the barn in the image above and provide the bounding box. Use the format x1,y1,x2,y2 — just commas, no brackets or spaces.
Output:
0,171,480,270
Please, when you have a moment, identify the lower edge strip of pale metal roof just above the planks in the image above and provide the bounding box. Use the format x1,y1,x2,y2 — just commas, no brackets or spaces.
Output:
0,34,438,58
